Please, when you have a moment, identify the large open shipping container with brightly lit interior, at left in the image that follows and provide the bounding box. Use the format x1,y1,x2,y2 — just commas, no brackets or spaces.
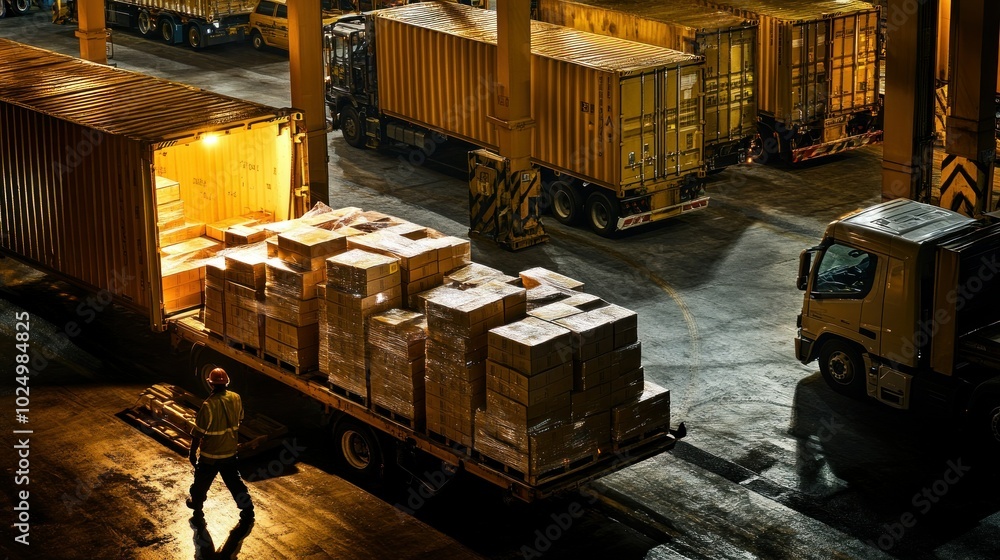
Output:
0,39,306,329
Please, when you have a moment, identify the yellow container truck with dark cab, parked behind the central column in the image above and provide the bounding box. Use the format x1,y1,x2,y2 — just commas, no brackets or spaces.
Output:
324,3,708,235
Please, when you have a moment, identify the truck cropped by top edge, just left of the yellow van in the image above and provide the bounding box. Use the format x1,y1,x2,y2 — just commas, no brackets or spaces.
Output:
104,0,257,49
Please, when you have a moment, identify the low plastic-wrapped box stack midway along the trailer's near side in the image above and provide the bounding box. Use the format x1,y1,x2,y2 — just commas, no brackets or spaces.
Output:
368,309,427,429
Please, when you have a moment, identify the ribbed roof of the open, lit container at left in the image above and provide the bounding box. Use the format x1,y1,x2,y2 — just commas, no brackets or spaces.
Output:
0,38,291,143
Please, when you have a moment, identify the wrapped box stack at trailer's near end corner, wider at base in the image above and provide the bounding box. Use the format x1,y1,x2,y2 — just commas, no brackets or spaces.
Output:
475,317,610,476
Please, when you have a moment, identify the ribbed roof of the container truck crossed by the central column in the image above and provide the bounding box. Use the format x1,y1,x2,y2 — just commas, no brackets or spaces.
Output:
374,2,702,73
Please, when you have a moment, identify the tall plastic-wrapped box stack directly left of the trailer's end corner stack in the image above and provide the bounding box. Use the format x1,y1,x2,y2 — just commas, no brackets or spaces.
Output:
425,289,504,448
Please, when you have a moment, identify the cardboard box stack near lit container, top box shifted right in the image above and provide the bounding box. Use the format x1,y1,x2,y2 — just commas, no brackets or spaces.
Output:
262,226,347,373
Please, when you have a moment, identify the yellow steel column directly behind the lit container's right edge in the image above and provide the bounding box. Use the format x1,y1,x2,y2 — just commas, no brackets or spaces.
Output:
288,0,330,207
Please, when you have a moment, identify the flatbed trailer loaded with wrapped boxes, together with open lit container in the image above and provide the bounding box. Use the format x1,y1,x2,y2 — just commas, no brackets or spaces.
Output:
0,39,684,501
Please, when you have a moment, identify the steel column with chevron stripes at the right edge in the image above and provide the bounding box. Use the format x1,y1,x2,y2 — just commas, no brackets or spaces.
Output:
941,0,1000,216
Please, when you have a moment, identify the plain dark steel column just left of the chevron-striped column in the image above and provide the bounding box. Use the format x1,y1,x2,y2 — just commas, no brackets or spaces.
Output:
882,0,938,201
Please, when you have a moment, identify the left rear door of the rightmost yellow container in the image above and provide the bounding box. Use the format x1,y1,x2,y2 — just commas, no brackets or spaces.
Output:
790,20,827,123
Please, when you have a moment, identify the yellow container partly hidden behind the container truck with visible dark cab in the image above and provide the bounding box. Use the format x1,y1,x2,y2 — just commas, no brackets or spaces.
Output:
537,0,757,171
